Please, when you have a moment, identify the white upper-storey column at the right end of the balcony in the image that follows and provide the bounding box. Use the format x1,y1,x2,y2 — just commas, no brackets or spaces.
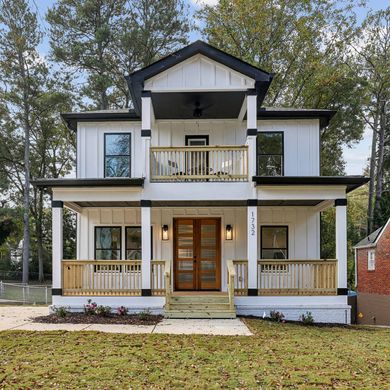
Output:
246,90,257,184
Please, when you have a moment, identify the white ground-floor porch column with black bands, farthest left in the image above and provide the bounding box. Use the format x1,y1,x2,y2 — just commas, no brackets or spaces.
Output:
51,200,64,295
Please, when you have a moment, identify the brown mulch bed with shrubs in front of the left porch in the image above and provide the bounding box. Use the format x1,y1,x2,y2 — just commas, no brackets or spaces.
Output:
33,313,164,325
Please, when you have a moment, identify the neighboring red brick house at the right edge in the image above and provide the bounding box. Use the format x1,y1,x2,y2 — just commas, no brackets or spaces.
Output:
354,219,390,325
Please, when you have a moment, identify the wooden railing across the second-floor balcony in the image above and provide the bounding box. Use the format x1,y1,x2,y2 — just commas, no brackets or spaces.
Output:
150,145,248,182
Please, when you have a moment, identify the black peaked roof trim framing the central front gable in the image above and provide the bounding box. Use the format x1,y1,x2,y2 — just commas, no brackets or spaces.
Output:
125,41,274,114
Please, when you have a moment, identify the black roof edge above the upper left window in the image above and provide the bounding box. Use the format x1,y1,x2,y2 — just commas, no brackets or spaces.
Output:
61,109,141,131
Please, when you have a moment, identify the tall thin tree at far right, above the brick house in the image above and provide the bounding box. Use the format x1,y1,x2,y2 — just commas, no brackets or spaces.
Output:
352,7,390,234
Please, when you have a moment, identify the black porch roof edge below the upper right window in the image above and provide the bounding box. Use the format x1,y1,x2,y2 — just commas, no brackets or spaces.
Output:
253,176,370,192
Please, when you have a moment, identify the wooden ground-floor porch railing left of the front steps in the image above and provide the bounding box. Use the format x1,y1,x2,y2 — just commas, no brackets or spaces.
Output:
62,260,165,296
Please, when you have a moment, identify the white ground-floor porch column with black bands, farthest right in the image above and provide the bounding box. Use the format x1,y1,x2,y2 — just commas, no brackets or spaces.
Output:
335,199,348,295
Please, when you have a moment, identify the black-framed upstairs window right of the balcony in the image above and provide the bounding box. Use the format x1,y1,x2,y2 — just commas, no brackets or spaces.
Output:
257,131,284,176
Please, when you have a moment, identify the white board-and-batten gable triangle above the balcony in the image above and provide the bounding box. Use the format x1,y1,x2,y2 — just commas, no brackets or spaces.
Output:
144,54,255,92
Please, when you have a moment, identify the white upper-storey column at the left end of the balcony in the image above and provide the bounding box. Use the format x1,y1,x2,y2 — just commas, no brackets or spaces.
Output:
141,91,153,181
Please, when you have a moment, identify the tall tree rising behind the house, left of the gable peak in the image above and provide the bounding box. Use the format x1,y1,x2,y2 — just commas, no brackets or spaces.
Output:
47,0,189,109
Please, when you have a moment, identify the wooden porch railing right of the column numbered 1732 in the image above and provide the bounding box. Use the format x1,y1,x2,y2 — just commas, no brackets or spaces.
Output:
257,260,337,295
